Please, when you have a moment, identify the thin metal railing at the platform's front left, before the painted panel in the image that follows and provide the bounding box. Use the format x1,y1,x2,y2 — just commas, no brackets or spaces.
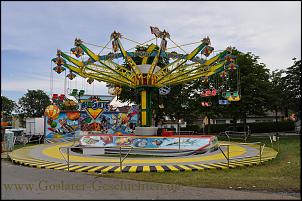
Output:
59,146,133,173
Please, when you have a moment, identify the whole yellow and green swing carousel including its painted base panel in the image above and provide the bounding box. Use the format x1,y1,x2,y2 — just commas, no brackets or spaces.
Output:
47,27,240,156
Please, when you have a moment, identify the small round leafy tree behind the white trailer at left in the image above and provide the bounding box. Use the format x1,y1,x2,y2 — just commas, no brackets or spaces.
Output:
18,90,51,117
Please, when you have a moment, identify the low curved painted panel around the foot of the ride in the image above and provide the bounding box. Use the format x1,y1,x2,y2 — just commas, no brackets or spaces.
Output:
79,134,218,156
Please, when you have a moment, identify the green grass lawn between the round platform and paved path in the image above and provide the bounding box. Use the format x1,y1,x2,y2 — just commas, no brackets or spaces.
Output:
100,136,301,192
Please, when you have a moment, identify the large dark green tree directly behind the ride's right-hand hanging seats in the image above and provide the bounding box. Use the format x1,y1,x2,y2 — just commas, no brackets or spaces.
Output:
186,50,270,130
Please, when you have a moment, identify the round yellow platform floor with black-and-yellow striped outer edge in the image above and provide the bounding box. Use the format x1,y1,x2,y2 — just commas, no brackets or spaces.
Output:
9,142,278,173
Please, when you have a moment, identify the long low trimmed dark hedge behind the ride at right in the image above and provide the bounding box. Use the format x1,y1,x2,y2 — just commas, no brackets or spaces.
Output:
181,121,295,134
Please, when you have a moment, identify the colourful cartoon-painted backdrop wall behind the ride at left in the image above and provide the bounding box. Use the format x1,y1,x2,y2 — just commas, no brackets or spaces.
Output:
45,106,138,142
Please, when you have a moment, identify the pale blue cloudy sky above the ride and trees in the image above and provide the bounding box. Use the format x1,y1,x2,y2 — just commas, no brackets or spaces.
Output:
1,1,301,105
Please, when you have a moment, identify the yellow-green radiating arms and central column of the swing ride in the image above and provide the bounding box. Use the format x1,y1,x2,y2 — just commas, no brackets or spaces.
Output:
52,27,240,127
